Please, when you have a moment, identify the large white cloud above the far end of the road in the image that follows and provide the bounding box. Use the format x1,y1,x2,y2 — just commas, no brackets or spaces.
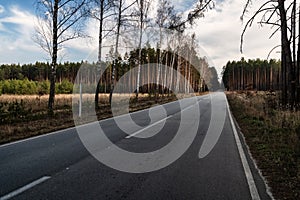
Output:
189,0,280,77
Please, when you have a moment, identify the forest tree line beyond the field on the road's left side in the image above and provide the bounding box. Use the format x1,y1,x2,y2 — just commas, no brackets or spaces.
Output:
0,44,219,95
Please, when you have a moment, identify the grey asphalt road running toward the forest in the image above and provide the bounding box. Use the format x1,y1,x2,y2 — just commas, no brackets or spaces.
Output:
0,93,270,200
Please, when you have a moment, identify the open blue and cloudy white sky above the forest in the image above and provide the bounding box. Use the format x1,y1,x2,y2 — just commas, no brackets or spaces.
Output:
0,0,280,77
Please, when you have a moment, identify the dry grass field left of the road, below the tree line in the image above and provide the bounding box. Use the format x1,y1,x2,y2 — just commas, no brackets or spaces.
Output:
0,94,185,144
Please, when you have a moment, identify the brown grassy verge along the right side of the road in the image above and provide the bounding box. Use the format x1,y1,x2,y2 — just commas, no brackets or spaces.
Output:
227,91,300,200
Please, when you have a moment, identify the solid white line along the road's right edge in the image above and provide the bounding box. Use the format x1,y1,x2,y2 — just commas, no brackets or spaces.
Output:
226,98,260,200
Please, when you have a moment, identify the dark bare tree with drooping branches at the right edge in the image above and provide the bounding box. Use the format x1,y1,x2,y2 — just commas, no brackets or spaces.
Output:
241,0,300,109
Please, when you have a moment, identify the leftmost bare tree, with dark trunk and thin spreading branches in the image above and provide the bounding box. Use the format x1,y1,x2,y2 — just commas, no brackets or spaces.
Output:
33,0,86,113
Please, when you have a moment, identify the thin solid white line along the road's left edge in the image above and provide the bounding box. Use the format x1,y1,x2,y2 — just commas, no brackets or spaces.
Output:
0,94,210,148
